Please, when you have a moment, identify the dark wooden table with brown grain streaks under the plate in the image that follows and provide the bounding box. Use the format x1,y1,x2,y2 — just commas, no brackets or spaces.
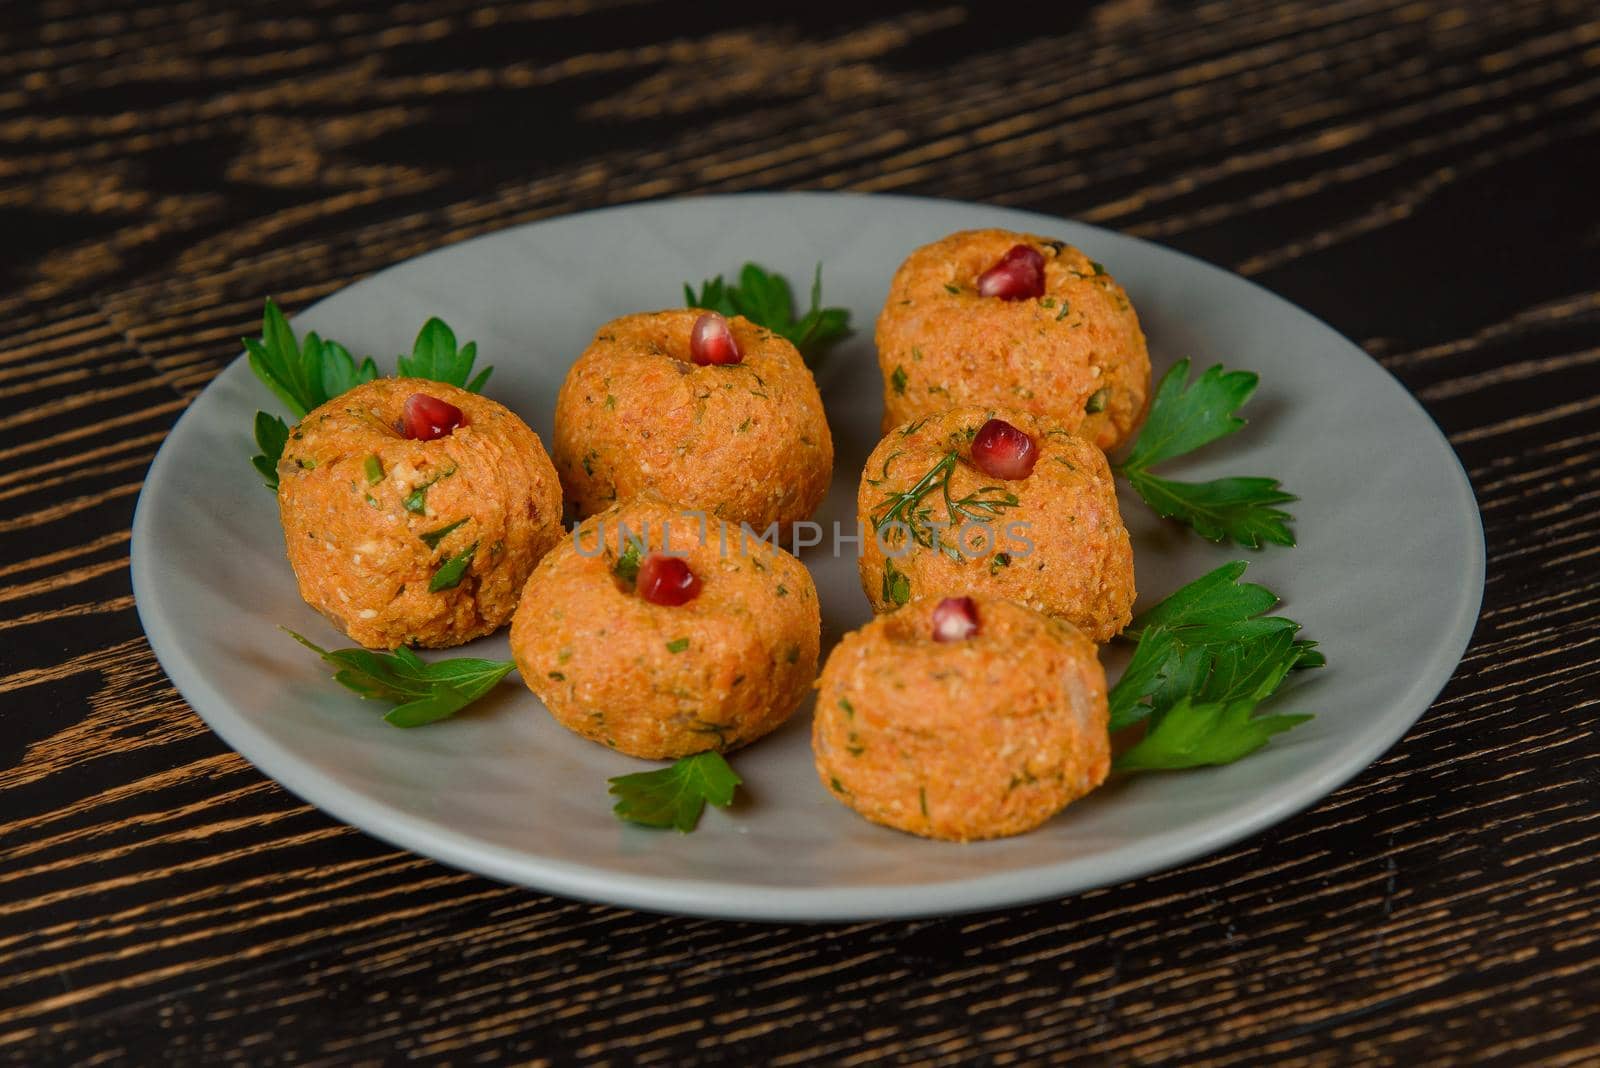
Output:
0,0,1600,1068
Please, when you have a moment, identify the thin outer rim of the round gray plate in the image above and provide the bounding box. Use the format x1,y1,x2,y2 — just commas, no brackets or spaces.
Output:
130,190,1486,923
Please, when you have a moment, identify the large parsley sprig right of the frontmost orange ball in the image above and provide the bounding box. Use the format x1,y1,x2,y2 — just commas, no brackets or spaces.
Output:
1110,561,1326,771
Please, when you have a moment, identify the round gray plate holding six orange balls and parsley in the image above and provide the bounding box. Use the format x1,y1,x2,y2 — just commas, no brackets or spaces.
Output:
133,193,1483,919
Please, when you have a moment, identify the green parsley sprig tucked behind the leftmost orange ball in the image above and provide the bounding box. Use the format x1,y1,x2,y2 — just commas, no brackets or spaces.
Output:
243,297,494,492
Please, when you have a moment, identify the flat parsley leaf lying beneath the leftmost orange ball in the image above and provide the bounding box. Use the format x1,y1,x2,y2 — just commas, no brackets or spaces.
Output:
285,628,517,727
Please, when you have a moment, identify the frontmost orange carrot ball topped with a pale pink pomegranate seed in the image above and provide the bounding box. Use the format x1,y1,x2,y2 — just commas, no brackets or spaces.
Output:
811,596,1110,841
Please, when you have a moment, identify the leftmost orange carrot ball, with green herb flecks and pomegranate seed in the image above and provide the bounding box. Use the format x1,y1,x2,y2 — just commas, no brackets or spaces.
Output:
278,379,562,649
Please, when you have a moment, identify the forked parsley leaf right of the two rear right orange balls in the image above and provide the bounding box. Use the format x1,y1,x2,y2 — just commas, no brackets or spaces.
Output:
1117,360,1298,548
